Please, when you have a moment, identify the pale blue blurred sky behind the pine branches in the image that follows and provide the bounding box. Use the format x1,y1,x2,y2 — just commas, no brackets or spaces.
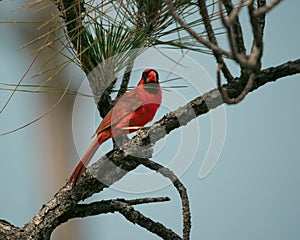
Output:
0,1,300,240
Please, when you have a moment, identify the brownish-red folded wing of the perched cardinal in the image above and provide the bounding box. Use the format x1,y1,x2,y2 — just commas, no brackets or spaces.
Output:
95,88,143,134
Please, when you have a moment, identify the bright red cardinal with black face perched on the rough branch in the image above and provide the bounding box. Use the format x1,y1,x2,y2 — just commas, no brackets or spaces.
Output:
69,69,162,187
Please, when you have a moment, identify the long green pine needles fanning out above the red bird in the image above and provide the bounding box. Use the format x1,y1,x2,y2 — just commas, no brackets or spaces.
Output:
3,0,223,94
